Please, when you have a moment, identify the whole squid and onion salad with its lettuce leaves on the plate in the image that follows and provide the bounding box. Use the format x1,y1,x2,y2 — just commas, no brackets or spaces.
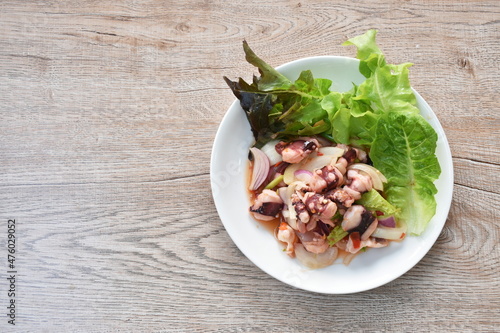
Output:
225,30,441,268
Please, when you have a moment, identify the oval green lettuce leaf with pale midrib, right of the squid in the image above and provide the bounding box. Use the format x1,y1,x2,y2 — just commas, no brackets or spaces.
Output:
370,113,441,235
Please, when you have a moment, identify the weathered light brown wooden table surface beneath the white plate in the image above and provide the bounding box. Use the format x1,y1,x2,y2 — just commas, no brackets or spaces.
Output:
0,0,500,332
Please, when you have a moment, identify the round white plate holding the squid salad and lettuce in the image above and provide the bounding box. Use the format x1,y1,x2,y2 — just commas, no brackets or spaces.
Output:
210,56,453,294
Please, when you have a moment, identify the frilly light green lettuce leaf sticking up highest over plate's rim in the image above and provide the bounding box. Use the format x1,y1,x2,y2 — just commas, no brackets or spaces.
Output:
331,30,419,147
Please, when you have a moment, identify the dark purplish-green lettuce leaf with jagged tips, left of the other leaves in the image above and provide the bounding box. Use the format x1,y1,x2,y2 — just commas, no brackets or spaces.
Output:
224,42,341,144
